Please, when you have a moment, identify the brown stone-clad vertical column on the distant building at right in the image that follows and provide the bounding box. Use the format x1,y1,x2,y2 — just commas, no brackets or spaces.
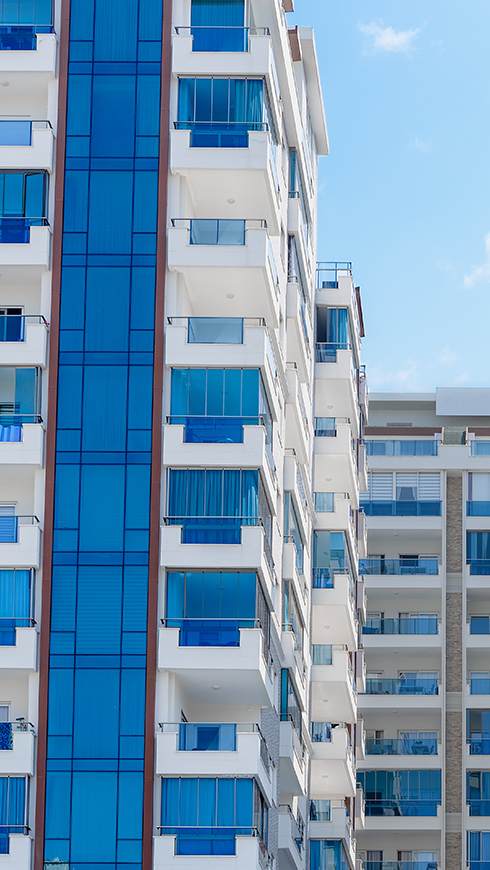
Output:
445,477,464,870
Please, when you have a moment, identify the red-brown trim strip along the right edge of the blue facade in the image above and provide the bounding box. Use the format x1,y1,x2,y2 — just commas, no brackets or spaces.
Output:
142,0,172,870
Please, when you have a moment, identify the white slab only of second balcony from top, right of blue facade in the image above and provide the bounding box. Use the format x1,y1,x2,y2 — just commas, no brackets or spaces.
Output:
170,126,280,235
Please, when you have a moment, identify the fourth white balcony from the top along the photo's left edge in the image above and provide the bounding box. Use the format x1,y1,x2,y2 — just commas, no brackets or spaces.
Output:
0,314,48,368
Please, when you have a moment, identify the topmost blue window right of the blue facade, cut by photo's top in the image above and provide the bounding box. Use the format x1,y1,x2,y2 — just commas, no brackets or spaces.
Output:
191,0,248,51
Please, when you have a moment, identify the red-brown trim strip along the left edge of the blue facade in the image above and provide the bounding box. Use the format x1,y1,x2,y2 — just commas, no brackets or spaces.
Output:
34,0,70,870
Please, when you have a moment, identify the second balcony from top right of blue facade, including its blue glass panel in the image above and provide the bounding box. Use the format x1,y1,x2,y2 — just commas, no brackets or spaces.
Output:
170,126,281,235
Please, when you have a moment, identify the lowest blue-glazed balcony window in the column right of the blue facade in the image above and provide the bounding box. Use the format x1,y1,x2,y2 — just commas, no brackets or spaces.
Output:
161,777,268,855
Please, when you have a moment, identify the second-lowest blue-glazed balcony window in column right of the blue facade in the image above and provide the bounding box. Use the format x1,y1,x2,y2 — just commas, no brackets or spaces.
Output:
166,571,270,646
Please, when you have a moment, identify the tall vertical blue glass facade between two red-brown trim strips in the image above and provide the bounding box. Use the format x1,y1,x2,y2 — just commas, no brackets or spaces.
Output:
45,0,166,870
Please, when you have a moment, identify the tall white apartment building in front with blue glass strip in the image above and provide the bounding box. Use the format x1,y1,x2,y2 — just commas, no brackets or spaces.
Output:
0,0,367,870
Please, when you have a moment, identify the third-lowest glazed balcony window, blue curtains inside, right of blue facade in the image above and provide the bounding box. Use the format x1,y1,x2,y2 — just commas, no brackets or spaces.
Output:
168,468,272,552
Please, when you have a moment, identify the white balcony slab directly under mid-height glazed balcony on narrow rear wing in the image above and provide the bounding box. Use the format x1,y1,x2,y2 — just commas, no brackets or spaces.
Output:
311,574,357,650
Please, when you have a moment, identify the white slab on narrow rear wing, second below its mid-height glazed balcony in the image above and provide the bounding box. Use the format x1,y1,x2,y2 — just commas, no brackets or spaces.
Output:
311,651,357,724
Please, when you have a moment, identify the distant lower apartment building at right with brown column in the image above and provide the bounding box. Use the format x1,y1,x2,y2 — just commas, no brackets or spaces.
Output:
358,388,490,870
